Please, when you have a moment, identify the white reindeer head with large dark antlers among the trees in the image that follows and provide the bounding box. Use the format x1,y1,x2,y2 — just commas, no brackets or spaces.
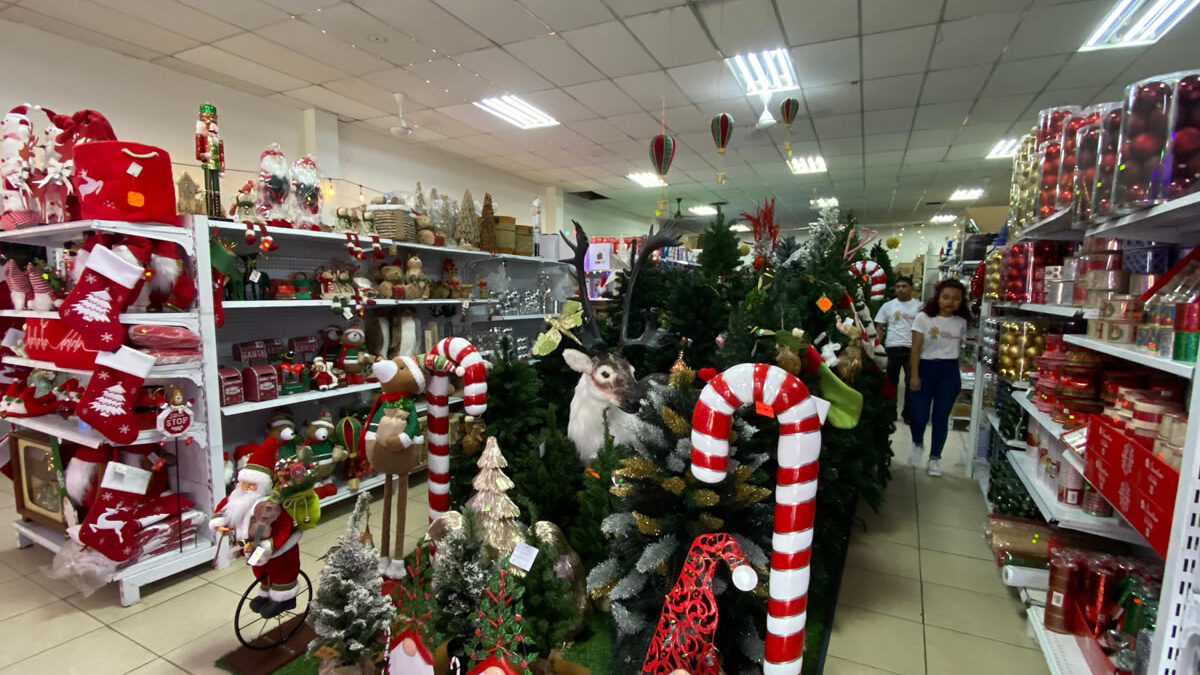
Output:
563,221,679,464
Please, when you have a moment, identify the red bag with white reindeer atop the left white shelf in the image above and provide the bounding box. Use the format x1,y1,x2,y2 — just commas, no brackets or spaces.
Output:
72,141,179,225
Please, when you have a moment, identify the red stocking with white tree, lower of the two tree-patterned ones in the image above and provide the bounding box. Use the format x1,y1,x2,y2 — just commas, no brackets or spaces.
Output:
76,345,155,446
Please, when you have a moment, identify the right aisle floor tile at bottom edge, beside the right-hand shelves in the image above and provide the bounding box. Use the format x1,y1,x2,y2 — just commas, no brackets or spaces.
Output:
925,626,1049,675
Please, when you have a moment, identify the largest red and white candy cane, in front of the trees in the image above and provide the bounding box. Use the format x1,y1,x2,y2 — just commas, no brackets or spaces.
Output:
691,363,821,675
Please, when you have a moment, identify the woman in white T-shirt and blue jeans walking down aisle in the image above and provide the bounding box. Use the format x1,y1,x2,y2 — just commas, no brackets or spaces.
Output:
908,279,971,476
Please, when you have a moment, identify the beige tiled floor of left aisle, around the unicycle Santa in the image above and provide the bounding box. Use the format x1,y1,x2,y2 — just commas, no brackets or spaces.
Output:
0,478,428,675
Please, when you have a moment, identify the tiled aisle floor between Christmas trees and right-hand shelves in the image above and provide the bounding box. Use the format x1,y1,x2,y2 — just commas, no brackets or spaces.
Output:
824,425,1049,675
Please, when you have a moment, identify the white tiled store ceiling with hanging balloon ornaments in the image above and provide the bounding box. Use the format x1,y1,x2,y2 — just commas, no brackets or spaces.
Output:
9,0,1200,227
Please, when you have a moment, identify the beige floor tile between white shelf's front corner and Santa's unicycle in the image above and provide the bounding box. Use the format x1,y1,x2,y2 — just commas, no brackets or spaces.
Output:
112,584,240,659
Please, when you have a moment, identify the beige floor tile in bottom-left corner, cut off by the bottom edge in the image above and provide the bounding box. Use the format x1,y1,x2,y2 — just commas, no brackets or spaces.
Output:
0,627,155,675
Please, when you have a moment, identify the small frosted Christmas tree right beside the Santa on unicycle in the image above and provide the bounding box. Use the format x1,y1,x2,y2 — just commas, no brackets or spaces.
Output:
308,494,395,675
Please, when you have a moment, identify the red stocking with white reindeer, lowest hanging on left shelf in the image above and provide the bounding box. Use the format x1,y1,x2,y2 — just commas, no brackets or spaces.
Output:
79,461,150,562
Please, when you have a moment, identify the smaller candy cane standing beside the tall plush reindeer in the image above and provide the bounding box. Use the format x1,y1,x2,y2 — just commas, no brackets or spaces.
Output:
425,338,487,514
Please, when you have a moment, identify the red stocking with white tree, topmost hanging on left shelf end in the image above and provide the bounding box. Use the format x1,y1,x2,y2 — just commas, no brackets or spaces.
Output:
59,244,144,352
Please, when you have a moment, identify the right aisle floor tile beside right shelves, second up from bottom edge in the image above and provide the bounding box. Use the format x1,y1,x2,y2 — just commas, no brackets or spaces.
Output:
922,581,1037,649
